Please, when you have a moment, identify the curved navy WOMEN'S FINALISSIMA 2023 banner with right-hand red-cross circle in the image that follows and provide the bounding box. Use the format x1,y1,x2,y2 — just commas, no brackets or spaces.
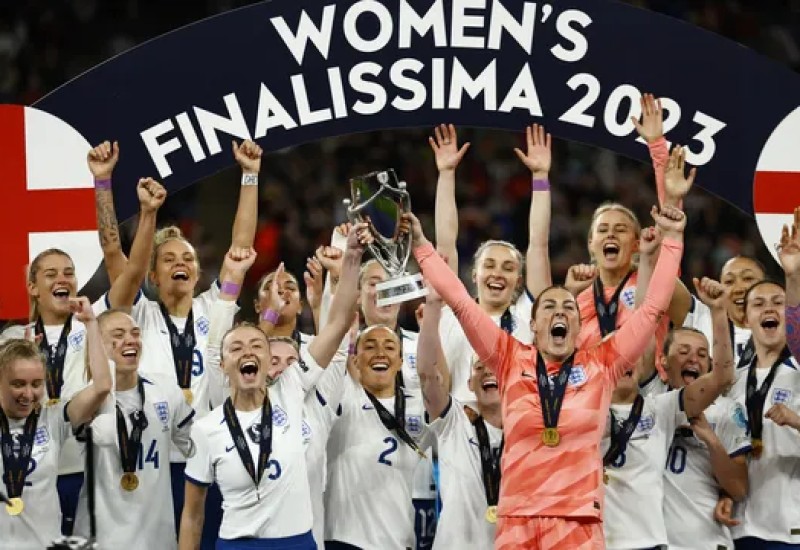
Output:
6,0,800,320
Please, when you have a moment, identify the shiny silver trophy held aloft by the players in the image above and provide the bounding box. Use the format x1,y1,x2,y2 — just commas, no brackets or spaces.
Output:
344,168,428,307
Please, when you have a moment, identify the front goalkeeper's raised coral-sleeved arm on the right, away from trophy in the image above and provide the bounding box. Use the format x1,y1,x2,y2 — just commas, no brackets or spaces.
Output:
600,206,686,384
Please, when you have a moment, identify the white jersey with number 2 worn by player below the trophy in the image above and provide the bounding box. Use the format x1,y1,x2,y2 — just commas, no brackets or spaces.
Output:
325,376,430,550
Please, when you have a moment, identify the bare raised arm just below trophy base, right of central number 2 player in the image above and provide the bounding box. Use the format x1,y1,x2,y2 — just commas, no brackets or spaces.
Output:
417,286,450,419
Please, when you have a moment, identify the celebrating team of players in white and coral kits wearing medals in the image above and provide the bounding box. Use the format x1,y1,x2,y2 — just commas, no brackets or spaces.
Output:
0,94,800,550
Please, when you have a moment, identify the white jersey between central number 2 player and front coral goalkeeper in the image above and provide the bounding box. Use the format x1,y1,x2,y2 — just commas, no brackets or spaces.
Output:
429,398,496,550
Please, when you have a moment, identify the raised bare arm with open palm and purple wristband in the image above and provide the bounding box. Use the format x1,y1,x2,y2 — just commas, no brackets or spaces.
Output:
514,124,553,298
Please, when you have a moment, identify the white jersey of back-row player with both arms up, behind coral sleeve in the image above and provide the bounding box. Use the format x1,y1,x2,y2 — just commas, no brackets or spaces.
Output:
439,291,533,405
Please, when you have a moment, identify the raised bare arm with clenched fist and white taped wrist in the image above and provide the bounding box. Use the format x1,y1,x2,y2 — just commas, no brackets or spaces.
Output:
220,140,262,280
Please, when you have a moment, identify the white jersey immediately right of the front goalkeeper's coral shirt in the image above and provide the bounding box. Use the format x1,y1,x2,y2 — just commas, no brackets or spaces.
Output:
600,391,686,550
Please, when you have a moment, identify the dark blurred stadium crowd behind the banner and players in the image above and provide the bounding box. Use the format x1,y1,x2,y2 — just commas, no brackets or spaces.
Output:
0,0,800,332
